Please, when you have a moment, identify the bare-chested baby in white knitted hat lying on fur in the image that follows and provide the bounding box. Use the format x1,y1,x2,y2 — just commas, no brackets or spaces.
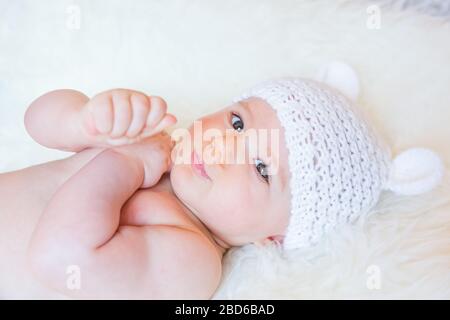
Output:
0,63,442,299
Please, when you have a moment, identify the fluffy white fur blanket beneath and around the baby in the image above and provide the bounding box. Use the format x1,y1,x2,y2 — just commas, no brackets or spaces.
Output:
0,0,450,299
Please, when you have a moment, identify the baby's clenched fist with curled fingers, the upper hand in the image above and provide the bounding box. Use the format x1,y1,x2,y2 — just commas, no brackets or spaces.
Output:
81,89,177,146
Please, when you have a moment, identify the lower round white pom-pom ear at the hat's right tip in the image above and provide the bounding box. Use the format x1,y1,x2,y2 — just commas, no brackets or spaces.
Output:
387,148,444,195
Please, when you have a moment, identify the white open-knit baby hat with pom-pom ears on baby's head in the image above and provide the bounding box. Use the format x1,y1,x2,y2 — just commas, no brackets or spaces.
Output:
234,71,443,249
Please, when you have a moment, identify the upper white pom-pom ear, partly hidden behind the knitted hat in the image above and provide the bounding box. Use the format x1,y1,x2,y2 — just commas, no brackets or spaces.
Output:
314,61,359,101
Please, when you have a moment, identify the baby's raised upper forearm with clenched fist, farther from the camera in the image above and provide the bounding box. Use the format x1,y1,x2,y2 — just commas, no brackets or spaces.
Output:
25,89,176,152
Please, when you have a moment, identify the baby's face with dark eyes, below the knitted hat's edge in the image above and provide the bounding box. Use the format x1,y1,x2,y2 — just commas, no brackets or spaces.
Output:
171,98,290,246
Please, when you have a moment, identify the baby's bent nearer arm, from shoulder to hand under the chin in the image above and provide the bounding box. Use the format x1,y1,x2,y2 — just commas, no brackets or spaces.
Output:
29,137,217,299
